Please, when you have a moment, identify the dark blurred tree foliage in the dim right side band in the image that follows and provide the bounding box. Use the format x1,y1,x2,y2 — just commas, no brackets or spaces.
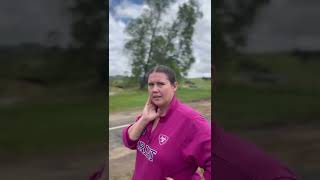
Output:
213,0,270,66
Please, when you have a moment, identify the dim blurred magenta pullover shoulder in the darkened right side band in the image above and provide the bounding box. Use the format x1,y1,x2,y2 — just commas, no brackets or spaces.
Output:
212,122,297,180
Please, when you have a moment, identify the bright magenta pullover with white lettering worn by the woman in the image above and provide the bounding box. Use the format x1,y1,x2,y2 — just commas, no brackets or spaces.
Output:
122,96,212,180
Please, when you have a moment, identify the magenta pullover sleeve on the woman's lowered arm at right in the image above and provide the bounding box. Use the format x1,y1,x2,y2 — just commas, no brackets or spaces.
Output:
182,117,211,180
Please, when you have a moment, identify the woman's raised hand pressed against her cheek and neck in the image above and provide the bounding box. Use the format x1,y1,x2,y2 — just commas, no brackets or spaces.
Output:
141,95,160,123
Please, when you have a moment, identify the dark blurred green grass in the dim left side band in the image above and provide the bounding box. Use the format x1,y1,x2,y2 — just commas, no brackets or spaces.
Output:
0,96,107,156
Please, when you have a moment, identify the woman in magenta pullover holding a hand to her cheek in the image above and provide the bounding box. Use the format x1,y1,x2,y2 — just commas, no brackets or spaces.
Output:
123,65,211,180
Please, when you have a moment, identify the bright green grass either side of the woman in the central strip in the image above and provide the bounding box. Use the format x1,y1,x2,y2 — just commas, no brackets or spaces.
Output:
109,79,211,112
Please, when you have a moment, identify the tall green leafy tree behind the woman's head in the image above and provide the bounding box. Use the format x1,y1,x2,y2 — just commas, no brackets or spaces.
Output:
125,0,202,88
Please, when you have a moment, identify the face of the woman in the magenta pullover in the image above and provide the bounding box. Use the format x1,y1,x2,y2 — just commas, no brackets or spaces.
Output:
148,72,177,108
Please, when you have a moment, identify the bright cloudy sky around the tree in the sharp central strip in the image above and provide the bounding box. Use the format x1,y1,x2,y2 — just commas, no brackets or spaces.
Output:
109,0,211,77
